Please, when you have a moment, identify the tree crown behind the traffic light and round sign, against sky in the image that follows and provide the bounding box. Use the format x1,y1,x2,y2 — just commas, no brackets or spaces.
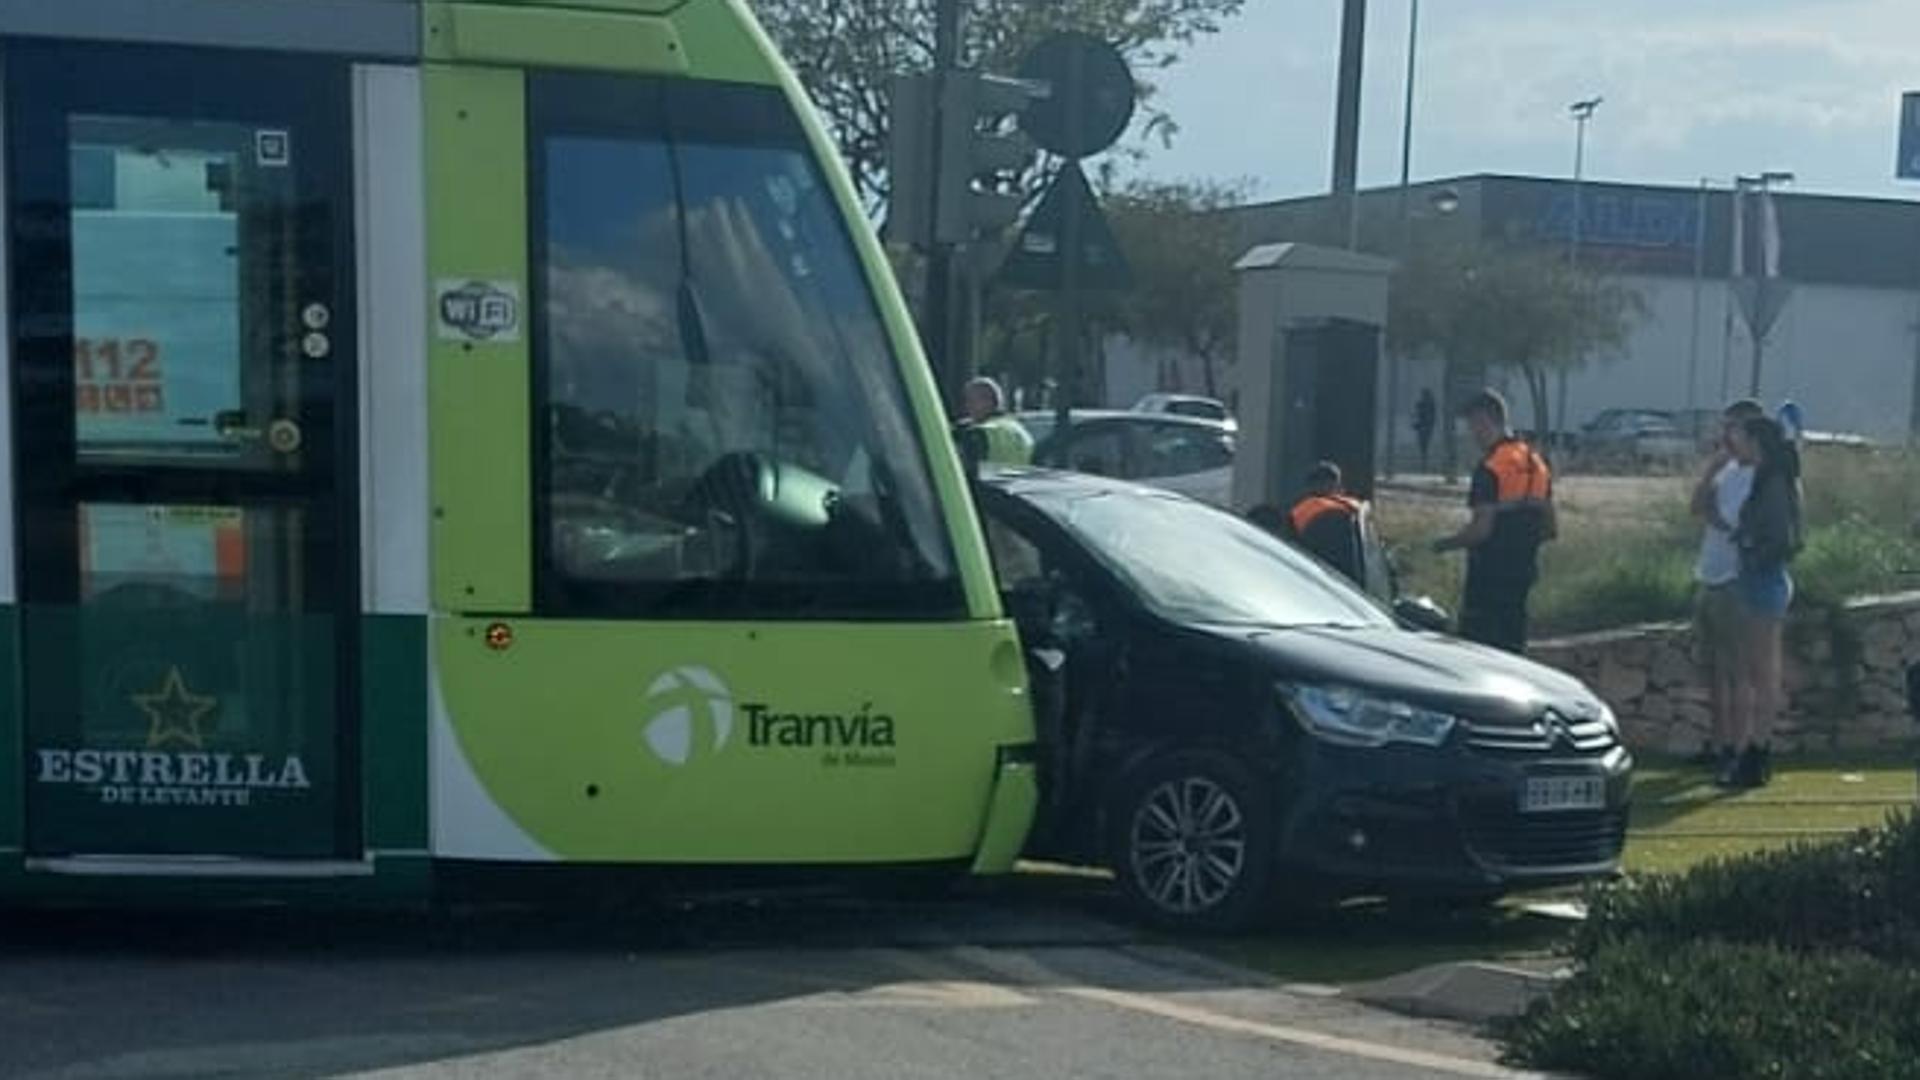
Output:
756,0,1244,208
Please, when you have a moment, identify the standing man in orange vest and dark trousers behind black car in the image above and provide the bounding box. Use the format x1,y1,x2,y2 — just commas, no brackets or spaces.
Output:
1434,390,1559,653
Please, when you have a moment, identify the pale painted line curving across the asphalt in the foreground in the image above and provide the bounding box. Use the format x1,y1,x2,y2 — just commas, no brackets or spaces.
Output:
954,945,1544,1080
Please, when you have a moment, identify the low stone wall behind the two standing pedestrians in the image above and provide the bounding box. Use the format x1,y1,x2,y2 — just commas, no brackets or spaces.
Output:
1530,592,1920,753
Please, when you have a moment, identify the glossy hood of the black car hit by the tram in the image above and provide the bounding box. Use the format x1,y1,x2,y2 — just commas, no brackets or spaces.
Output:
1204,626,1599,723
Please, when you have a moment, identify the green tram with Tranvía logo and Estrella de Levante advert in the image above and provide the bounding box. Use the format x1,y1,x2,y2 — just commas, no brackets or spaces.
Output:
0,0,1035,901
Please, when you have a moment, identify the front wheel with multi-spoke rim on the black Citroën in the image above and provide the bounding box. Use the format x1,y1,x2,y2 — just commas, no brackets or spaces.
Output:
1110,751,1279,934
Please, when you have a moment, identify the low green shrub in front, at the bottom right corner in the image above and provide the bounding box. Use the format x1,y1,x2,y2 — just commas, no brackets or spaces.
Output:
1498,936,1920,1080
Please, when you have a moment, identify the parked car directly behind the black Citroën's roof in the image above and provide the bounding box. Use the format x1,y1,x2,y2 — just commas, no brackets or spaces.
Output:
1016,409,1235,507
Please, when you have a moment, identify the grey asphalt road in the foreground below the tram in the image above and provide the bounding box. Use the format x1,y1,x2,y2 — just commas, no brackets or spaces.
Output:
0,901,1536,1080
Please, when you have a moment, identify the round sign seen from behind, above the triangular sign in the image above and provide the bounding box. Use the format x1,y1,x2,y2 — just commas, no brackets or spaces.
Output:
1020,33,1139,160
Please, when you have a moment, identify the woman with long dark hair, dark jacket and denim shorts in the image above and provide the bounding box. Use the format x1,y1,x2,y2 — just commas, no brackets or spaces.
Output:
1715,417,1803,788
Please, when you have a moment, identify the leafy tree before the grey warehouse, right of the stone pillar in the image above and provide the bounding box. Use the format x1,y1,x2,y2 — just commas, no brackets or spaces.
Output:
1386,244,1645,434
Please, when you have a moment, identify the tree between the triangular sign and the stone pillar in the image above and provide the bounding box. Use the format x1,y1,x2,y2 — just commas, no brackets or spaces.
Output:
1106,181,1246,398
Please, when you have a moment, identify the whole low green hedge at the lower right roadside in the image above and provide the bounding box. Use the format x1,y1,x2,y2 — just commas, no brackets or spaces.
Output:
1500,813,1920,1080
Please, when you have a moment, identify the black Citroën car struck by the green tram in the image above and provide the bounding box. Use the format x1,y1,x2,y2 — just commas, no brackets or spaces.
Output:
977,469,1632,928
